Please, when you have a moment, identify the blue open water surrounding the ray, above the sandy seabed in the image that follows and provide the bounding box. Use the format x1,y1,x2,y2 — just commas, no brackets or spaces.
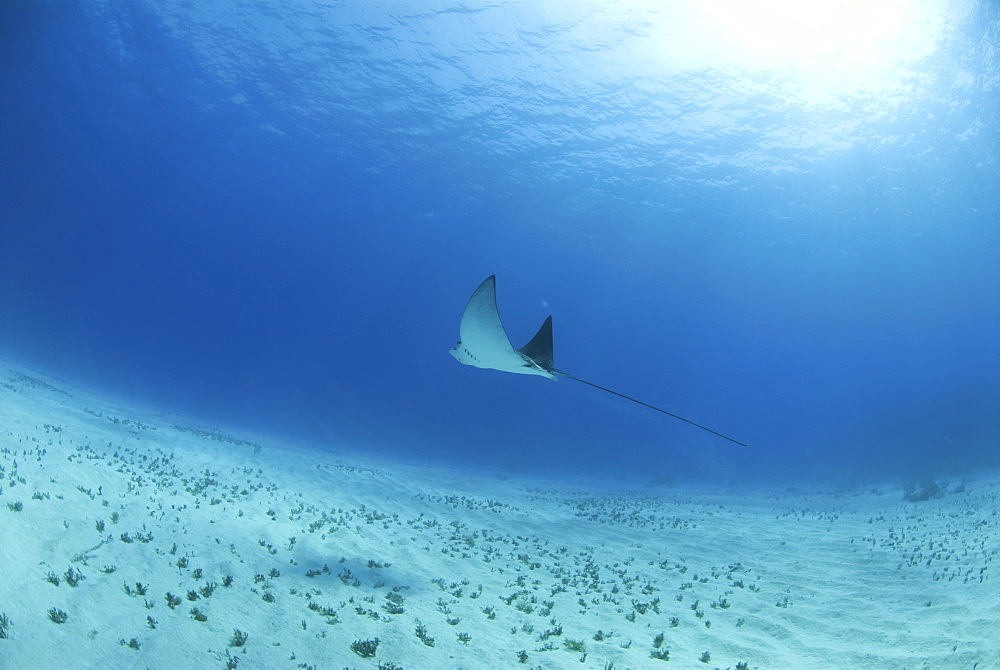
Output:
0,0,1000,482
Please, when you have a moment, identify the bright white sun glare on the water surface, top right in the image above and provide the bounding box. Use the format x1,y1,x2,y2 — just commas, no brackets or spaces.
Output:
650,0,954,92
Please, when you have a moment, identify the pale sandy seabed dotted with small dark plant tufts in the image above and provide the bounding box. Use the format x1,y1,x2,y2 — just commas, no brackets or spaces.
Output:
0,362,1000,670
